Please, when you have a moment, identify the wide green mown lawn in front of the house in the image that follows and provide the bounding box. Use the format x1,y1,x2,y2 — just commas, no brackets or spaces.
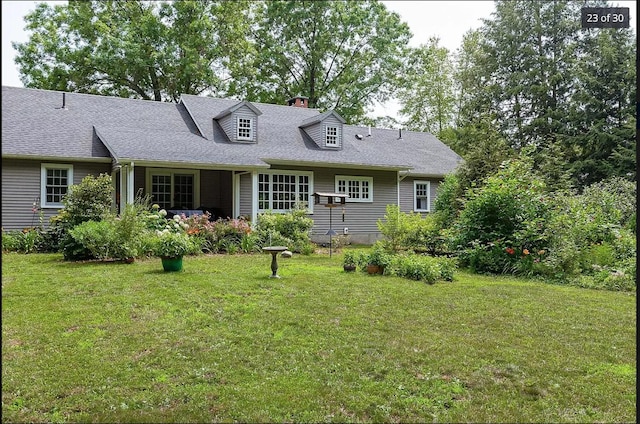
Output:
2,254,636,423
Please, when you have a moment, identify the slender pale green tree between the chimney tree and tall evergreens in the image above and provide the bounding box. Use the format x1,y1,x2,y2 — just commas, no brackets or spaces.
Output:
398,37,455,134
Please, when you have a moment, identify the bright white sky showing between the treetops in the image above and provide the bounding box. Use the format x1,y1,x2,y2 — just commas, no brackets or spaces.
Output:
2,0,637,116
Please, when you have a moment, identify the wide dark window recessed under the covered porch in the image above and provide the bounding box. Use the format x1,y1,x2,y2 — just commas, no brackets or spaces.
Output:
147,168,200,209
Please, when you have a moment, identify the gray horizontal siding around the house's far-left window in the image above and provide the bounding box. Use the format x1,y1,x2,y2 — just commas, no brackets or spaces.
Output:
2,159,111,231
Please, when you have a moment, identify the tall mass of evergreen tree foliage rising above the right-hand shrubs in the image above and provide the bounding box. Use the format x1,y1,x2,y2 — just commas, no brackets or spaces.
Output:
454,0,636,189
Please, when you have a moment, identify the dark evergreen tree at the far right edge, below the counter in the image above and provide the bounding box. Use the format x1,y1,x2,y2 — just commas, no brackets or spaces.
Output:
569,25,637,187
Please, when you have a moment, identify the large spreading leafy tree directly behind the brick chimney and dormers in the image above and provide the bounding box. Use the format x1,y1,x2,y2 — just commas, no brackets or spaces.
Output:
232,0,411,122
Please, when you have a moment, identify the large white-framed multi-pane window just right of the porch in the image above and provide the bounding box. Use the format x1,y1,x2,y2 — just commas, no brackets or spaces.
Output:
258,172,313,212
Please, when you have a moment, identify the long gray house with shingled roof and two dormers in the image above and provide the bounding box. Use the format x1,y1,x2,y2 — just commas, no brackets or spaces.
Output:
2,87,462,243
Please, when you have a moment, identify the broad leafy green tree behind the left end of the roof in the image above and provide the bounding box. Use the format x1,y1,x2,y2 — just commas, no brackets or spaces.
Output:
13,0,250,101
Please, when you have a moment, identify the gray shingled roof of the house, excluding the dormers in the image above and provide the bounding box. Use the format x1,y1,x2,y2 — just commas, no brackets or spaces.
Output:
2,87,462,177
